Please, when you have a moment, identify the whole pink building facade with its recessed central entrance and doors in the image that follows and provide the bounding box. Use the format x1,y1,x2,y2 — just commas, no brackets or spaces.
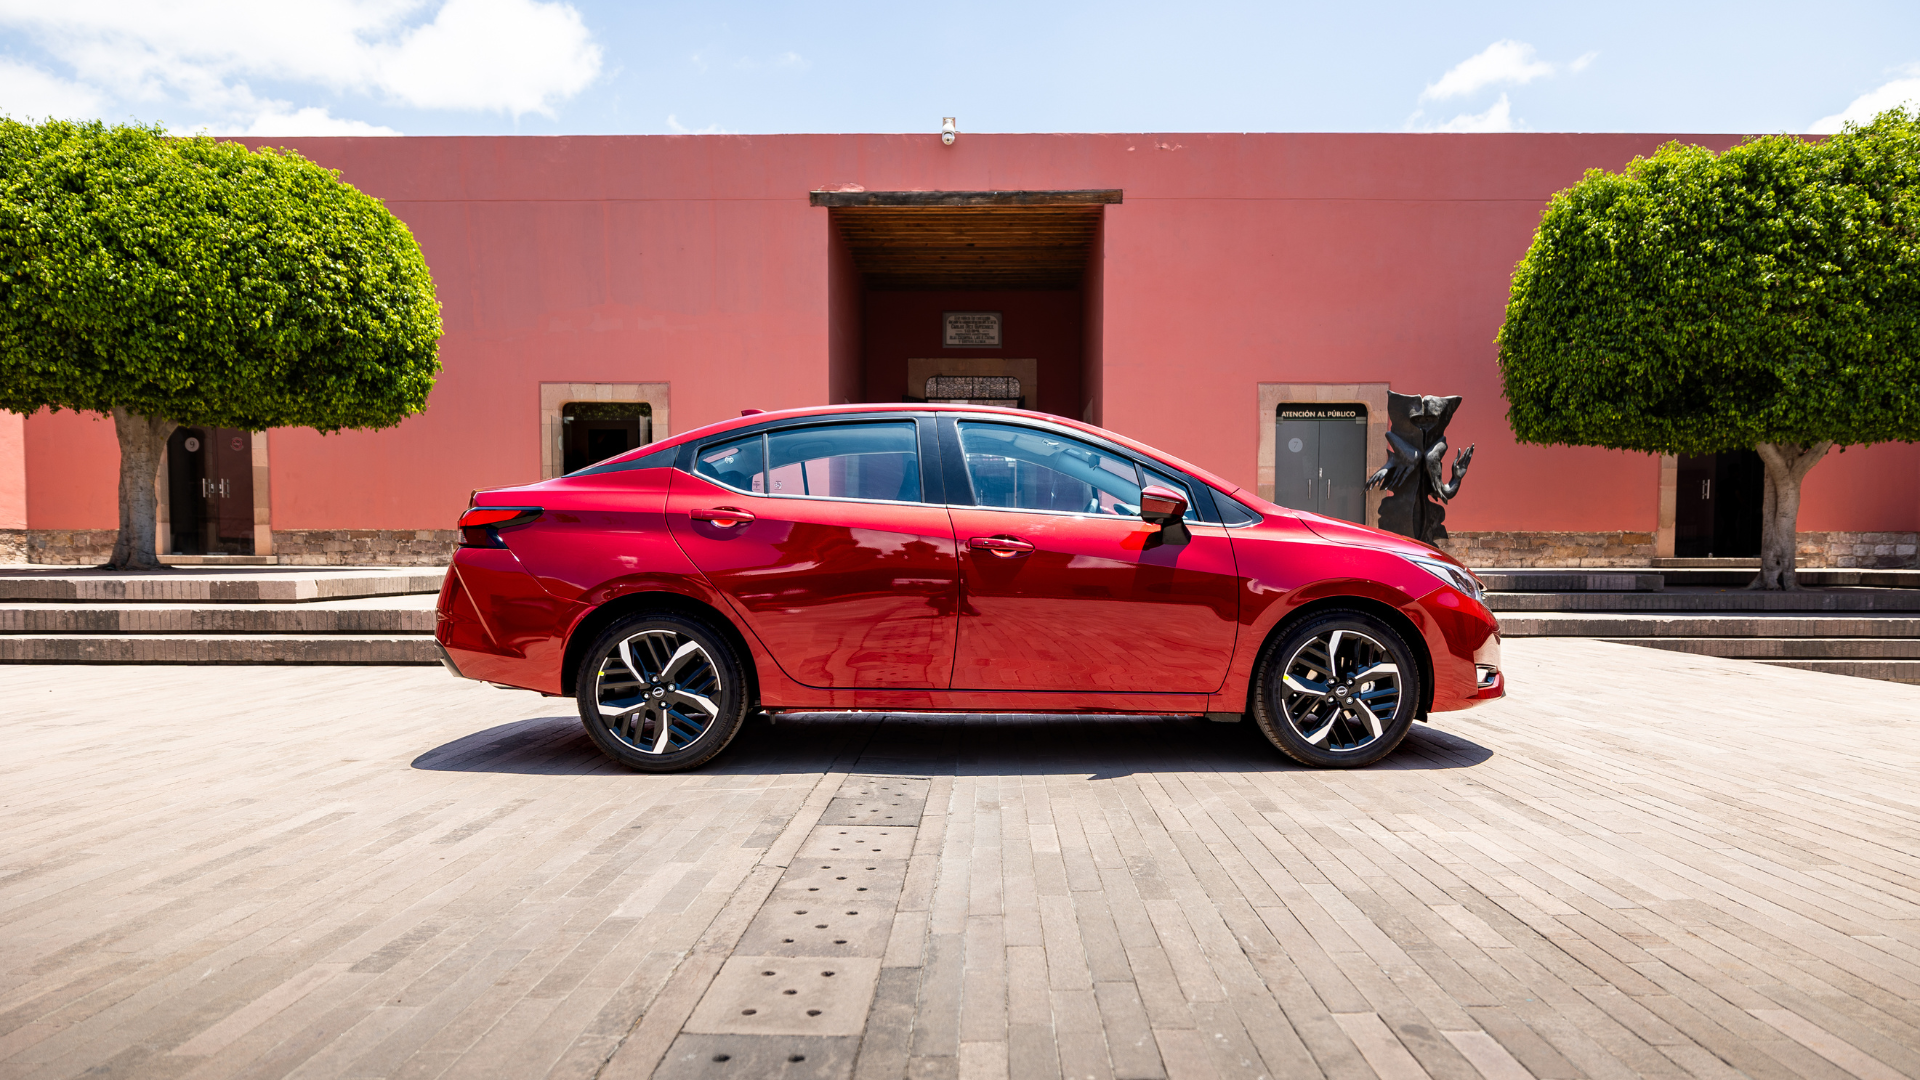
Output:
0,135,1920,567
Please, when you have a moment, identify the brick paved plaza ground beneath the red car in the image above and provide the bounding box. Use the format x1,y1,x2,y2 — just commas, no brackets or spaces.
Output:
0,638,1920,1080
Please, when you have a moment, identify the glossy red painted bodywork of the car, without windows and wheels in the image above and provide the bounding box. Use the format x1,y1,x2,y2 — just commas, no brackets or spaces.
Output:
436,404,1505,715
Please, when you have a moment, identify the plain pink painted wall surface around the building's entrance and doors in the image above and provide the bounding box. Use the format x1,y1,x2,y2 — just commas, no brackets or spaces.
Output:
27,135,1920,530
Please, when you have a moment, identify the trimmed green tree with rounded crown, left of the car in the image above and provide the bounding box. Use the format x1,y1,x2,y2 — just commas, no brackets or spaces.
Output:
0,119,440,569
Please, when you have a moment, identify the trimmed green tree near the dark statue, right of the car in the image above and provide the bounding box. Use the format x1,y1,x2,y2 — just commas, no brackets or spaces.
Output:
1498,110,1920,588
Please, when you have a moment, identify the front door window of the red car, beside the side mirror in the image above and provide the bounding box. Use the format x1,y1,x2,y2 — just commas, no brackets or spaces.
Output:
960,421,1140,517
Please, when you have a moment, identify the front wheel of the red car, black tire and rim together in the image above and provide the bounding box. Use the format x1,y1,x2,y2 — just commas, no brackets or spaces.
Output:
1254,611,1421,769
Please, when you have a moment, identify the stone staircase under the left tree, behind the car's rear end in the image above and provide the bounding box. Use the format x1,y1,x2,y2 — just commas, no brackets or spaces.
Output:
0,565,445,665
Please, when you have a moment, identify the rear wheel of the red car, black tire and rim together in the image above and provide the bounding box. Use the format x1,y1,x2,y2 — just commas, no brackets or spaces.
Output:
574,613,749,773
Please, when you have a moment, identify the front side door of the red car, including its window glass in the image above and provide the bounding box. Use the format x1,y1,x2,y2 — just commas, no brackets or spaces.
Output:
950,421,1238,694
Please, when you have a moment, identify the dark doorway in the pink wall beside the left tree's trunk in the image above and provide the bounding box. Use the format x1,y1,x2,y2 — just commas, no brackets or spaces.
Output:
167,427,253,555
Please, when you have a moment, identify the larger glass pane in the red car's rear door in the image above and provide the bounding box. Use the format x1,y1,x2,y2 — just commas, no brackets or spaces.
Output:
766,421,920,502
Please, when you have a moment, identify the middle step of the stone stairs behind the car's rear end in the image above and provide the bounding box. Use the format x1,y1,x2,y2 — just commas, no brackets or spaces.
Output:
0,594,438,634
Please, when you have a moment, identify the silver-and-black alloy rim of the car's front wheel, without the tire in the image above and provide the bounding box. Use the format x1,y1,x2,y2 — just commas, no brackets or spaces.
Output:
1279,630,1400,753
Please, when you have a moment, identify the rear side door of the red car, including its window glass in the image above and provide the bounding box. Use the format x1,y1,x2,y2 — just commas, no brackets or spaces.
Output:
666,419,958,690
